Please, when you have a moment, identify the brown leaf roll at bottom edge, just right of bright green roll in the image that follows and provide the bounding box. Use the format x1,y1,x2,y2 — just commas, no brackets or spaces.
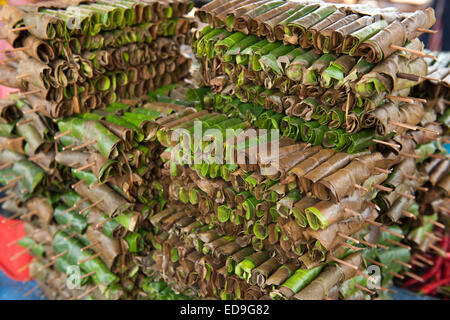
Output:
293,253,362,300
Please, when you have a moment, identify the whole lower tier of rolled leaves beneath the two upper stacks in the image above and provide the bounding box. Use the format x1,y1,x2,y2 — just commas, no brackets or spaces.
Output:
0,79,448,299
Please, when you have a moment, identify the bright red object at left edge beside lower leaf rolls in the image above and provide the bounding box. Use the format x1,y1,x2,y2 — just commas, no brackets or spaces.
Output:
0,215,33,281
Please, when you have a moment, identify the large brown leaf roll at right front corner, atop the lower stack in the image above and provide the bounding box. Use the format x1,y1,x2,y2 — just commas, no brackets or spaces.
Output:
313,152,384,202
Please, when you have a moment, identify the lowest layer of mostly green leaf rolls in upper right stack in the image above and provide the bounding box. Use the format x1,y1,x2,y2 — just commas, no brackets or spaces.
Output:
180,88,428,154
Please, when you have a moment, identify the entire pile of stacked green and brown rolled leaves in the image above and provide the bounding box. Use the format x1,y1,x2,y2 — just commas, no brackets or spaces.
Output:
0,0,450,300
